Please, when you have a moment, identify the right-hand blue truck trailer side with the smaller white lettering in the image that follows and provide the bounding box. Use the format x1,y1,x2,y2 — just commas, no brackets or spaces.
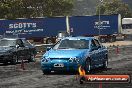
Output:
69,15,119,36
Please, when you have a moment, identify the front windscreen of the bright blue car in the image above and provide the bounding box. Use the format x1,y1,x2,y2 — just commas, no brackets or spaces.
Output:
53,39,89,49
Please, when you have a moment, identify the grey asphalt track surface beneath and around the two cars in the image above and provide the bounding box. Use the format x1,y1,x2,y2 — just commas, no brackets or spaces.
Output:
0,46,132,88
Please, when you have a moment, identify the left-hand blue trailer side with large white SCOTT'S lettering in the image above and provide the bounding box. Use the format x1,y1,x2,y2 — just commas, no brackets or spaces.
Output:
0,17,66,38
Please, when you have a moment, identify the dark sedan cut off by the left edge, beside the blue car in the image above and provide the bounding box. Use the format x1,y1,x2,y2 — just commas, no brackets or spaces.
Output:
0,38,37,64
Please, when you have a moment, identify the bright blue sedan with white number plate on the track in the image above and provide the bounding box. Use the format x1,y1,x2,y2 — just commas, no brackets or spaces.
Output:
41,37,108,74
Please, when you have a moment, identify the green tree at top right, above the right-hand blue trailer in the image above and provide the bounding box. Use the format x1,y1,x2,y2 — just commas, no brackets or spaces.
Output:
96,0,132,17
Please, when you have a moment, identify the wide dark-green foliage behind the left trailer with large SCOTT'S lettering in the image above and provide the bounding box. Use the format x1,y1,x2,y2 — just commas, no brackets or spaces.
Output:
0,0,73,19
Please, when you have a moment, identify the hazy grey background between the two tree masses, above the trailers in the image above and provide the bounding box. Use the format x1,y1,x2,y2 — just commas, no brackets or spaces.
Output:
72,0,98,16
